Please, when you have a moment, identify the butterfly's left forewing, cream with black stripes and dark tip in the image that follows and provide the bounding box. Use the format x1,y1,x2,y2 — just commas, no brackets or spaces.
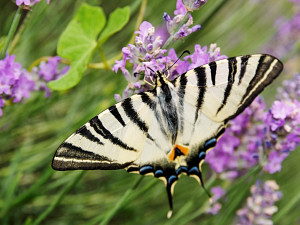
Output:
52,96,152,170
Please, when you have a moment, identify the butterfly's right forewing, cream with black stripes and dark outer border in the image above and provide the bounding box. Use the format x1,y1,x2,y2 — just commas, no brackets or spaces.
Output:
176,54,283,122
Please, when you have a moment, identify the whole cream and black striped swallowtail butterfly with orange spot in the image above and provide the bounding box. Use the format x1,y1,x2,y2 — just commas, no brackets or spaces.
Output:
52,54,283,217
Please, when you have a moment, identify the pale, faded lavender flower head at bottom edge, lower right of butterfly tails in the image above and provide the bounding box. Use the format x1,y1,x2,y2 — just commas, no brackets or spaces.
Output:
237,180,282,225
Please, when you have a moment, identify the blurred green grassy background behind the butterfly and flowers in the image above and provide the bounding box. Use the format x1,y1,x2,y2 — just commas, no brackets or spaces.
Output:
0,0,300,225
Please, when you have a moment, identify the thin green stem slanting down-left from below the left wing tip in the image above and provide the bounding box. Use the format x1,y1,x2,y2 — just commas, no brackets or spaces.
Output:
32,170,85,225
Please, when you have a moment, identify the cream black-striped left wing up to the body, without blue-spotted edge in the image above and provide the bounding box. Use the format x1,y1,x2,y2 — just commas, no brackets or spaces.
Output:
52,92,170,170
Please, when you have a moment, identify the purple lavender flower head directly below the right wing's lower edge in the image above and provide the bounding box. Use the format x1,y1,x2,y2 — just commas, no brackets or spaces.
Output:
206,97,265,179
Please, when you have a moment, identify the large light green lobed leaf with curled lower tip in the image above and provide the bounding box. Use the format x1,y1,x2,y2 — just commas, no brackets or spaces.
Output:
48,4,106,90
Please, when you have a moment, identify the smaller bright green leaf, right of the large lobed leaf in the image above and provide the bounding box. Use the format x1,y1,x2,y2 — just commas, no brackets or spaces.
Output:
99,6,130,44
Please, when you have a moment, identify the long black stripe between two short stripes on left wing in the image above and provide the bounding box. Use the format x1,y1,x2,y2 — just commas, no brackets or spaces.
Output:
89,116,137,151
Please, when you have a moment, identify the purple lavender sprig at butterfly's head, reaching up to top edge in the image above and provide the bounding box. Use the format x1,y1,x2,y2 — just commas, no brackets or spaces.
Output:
113,0,209,101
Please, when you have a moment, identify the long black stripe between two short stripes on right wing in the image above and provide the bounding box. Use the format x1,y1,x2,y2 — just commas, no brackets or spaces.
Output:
216,57,237,114
